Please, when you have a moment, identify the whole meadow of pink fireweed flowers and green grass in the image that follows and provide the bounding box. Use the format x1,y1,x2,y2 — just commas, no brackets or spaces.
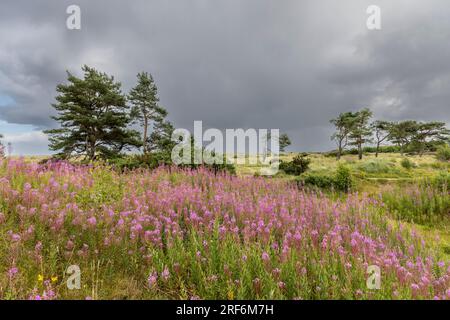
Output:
0,154,450,300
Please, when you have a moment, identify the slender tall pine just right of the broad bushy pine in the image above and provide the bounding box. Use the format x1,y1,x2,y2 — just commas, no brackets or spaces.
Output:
128,72,167,153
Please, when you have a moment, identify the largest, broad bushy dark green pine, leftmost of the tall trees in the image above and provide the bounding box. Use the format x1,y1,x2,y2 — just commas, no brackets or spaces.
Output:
45,65,141,160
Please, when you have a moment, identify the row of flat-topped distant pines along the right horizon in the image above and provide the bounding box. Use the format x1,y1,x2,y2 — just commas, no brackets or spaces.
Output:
330,108,450,159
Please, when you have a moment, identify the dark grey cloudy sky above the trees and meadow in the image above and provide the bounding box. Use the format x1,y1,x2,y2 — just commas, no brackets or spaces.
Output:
0,0,450,155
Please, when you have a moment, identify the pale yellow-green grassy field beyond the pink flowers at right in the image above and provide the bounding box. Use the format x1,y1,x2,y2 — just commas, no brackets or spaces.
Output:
237,153,450,261
